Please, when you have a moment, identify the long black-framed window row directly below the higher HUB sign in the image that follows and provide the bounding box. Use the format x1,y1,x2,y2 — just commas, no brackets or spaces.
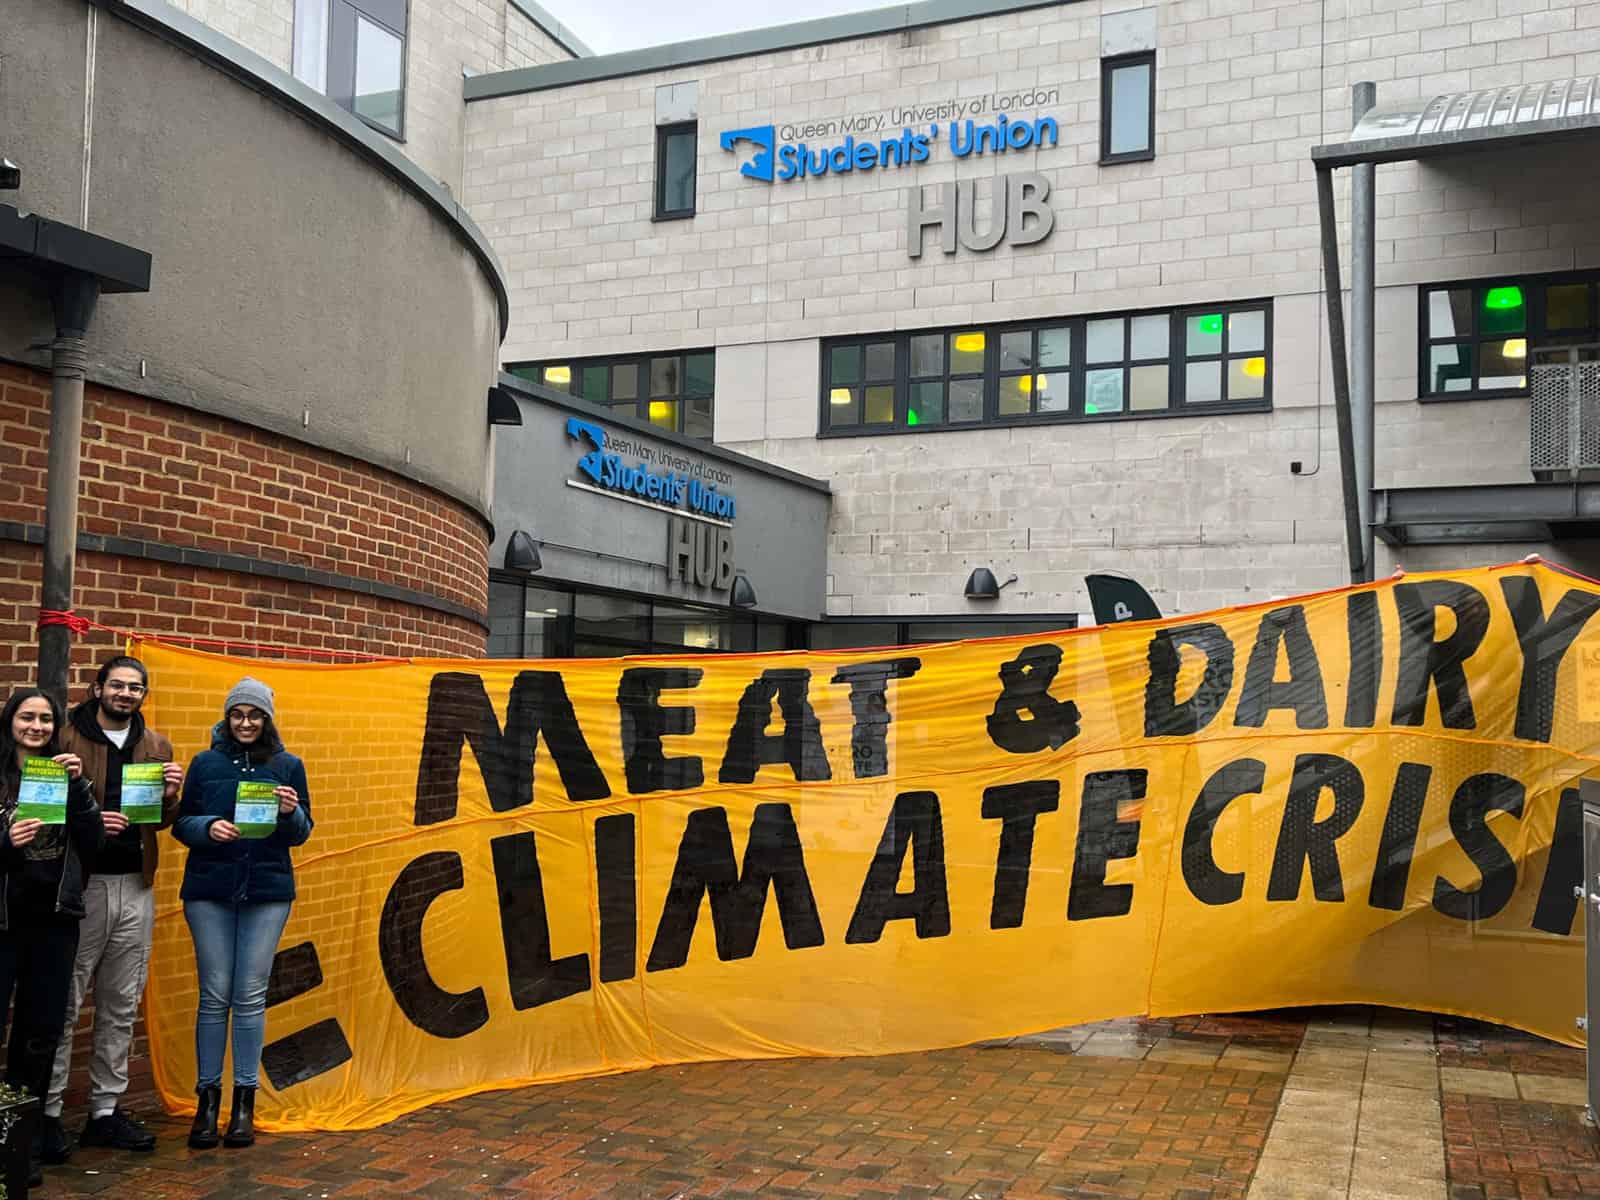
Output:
819,301,1272,435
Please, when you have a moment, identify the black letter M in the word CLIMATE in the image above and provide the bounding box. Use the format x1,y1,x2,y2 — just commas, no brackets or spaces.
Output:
645,805,822,971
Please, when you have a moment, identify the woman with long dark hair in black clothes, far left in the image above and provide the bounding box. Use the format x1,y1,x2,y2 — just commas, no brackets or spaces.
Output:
0,688,106,1182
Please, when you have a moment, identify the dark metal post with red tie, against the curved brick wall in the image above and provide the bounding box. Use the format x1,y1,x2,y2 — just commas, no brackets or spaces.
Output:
38,272,99,706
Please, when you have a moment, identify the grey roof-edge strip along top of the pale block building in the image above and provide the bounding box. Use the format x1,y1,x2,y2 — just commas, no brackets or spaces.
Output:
466,0,1078,101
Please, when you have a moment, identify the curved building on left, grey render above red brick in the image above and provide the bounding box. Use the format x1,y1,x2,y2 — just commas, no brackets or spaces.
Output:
0,0,588,686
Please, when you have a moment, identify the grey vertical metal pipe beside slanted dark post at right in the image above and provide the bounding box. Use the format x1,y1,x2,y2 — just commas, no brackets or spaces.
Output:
1350,83,1378,582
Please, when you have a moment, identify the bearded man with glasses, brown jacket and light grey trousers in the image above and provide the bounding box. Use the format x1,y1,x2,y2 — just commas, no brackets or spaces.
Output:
40,656,184,1163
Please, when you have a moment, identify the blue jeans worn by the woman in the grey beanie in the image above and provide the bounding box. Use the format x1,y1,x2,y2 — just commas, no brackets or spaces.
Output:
184,901,290,1088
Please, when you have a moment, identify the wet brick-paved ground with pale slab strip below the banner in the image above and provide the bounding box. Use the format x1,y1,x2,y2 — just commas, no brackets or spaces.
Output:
35,1008,1600,1200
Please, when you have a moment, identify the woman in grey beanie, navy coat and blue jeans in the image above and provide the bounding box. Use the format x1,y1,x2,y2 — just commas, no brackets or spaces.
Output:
173,675,312,1150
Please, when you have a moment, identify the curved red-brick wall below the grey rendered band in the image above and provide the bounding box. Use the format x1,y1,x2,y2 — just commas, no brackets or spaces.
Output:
0,365,488,686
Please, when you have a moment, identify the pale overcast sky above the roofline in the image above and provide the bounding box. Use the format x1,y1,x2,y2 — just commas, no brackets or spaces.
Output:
560,0,888,54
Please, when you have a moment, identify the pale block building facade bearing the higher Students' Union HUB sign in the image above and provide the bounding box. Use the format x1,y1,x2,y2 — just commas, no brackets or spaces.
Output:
462,0,1600,640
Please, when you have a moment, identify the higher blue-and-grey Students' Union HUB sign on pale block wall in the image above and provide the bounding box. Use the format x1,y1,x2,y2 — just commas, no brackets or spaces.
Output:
718,88,1061,258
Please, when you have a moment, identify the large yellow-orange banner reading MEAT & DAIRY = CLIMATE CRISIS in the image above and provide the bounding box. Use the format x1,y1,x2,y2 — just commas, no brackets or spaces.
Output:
139,565,1600,1130
